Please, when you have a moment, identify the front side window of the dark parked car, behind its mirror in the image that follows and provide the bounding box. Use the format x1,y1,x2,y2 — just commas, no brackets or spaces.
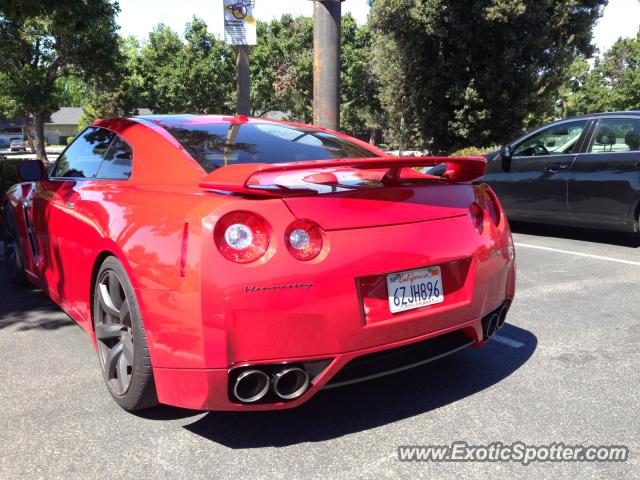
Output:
513,120,588,157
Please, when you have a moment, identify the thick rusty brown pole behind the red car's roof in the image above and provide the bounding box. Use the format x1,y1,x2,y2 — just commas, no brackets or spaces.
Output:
313,0,344,130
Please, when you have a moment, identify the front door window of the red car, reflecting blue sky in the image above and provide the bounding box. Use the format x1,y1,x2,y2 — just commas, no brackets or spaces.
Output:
52,127,115,178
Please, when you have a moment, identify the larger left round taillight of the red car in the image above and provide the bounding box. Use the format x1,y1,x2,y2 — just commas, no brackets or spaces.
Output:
213,212,269,263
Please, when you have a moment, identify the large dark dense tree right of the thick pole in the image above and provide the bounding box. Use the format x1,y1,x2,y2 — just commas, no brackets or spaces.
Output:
370,0,606,152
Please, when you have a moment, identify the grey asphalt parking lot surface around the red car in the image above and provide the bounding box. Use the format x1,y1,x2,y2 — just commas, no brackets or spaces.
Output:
0,225,640,479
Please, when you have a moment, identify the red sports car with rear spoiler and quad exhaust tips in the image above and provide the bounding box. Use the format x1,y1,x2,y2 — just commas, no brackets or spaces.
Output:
3,115,515,410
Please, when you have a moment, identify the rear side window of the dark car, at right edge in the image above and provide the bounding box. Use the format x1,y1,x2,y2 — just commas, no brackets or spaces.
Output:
589,118,640,153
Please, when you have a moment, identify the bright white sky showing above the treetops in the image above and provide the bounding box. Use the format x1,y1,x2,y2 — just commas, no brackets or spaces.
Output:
118,0,640,52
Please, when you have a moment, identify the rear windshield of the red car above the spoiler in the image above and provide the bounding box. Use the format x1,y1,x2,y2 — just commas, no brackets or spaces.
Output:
154,123,377,173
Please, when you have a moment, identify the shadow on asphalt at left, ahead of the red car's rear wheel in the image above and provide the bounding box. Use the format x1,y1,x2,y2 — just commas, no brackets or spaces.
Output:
0,257,75,331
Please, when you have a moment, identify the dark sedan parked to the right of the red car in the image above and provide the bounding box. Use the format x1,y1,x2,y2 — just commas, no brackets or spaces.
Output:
483,112,640,233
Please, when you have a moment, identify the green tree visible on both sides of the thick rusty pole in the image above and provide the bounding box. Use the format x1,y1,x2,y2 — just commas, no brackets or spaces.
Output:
251,14,380,132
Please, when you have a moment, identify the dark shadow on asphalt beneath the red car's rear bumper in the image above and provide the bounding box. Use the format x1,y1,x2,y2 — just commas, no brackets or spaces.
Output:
176,324,537,448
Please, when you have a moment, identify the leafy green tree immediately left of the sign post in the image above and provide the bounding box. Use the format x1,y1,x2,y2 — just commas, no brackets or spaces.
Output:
138,17,235,113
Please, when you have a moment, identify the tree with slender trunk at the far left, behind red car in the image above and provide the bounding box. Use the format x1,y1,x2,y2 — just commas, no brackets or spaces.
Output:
0,0,119,160
